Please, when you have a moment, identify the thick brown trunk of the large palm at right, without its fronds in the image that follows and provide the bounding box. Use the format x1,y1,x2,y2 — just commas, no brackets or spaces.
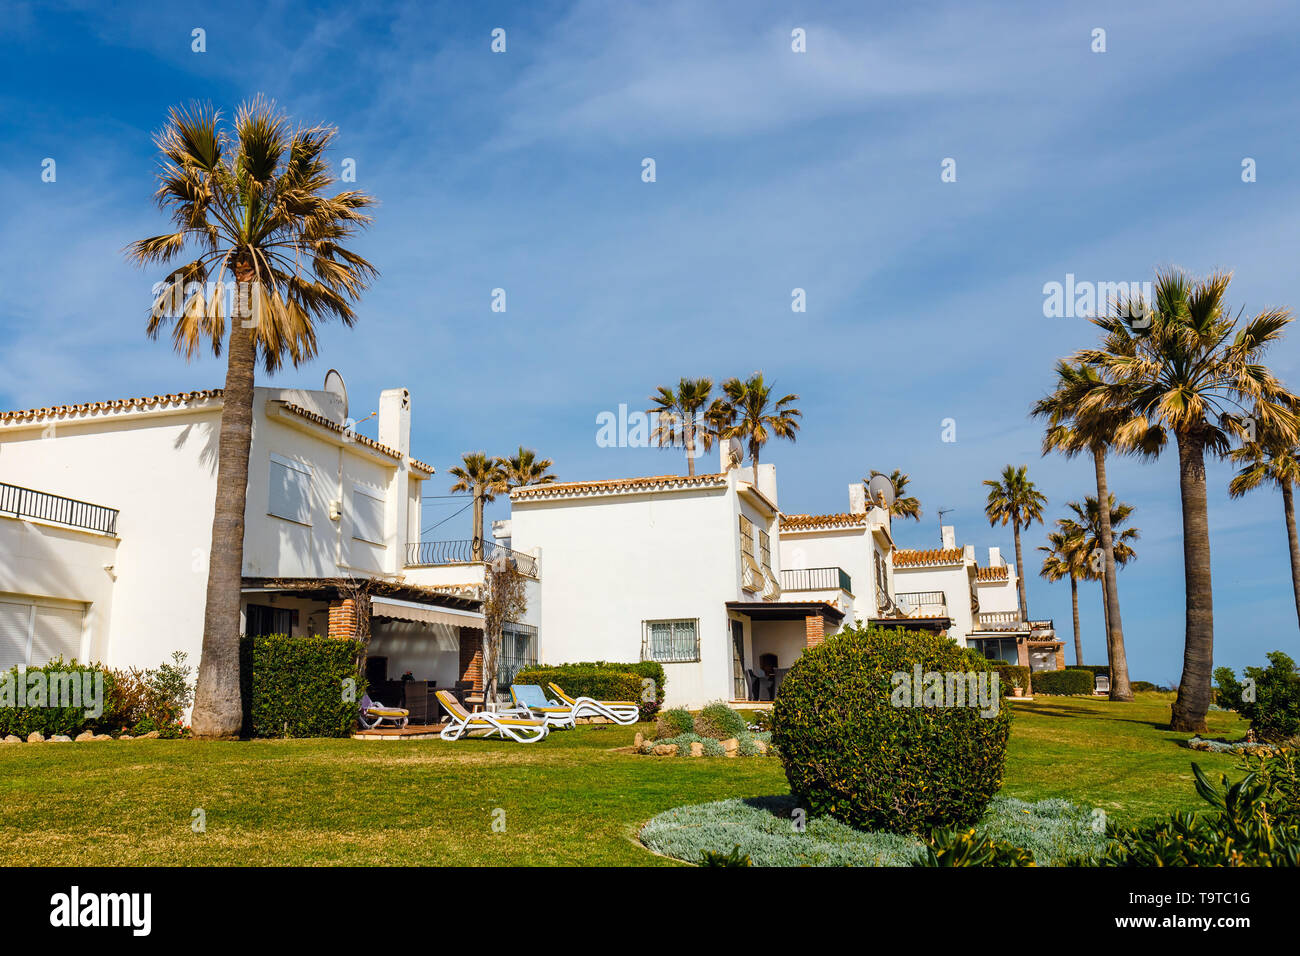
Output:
1170,433,1214,734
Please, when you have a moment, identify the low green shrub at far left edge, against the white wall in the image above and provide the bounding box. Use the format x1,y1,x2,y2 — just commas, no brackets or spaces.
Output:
0,657,113,739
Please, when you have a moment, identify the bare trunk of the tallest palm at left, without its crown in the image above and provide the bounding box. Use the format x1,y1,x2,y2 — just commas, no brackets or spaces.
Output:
191,291,256,737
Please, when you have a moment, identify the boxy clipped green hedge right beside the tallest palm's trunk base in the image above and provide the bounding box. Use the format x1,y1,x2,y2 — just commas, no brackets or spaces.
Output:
239,635,365,737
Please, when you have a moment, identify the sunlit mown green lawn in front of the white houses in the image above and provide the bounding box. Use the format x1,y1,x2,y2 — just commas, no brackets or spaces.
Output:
0,695,1245,865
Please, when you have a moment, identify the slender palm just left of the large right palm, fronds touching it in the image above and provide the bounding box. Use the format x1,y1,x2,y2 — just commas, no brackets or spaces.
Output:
1031,362,1164,701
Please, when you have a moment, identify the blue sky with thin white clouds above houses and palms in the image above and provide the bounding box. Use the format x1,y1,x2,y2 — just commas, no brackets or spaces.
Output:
0,0,1300,683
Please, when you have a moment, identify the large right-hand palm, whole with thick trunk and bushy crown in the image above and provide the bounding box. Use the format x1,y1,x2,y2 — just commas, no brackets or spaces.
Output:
1076,269,1300,732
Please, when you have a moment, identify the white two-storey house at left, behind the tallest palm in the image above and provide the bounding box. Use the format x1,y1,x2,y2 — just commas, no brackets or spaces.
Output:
0,373,536,717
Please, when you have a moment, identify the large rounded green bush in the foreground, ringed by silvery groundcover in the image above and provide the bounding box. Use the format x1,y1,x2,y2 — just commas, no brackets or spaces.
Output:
772,626,1011,832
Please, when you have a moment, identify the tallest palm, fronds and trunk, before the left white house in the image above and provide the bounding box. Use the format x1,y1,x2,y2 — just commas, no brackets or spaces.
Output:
126,98,378,737
